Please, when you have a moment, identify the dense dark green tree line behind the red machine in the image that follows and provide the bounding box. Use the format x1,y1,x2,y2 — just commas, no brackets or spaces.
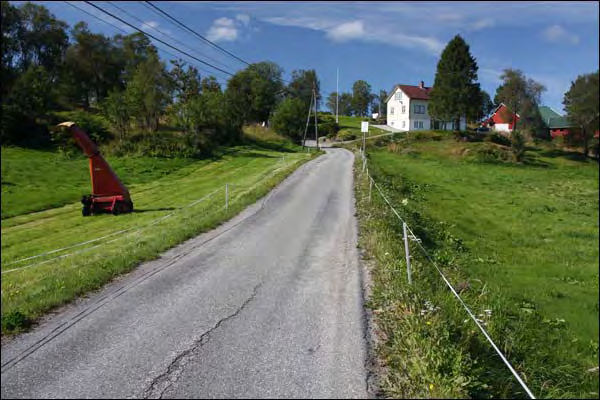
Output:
0,1,328,155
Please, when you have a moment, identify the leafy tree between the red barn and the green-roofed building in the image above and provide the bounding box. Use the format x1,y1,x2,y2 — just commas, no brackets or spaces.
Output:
494,68,545,161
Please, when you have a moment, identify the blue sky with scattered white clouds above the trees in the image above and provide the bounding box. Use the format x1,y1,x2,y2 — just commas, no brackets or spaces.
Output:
16,1,599,113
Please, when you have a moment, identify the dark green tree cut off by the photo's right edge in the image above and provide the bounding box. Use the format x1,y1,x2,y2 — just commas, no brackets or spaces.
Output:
563,71,600,157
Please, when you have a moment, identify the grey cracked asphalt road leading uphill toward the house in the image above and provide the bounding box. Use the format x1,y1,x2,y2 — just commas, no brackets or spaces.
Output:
1,149,369,398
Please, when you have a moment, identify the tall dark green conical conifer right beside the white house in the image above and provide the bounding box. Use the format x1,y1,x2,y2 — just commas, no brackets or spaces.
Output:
429,35,481,129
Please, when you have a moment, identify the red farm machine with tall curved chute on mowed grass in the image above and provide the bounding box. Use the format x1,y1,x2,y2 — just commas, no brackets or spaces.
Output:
58,122,133,217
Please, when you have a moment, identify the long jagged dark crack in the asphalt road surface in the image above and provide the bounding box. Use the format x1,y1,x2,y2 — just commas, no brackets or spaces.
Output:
142,283,262,399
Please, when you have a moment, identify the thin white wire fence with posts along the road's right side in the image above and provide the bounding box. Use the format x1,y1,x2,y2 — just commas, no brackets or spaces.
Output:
359,148,535,399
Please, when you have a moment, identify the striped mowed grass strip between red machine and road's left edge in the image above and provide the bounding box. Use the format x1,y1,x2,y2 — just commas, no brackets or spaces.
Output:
2,134,316,334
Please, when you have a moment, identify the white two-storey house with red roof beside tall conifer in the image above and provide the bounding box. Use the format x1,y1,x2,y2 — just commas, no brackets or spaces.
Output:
386,81,467,131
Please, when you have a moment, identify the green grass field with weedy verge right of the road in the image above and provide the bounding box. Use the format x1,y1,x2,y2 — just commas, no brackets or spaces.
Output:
357,133,599,398
